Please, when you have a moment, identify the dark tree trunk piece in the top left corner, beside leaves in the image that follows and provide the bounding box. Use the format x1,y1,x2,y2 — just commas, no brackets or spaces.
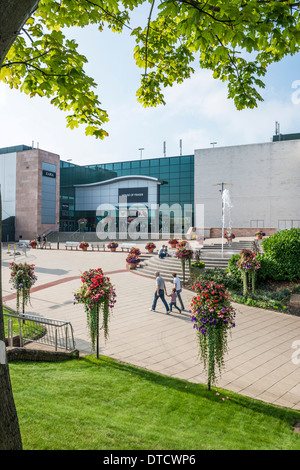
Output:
0,0,39,69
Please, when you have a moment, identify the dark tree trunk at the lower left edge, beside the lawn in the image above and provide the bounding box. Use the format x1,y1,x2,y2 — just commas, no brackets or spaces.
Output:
0,186,22,450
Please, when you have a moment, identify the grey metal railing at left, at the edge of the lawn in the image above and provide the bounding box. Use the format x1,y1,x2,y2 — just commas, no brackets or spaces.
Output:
4,313,75,351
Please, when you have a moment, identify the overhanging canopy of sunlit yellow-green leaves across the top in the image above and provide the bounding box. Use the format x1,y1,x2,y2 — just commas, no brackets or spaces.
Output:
0,0,300,138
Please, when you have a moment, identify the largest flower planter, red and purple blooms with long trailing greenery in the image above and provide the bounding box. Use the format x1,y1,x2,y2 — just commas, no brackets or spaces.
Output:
191,282,235,390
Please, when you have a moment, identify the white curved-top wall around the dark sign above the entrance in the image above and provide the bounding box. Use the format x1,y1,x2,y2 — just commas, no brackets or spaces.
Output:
75,178,157,211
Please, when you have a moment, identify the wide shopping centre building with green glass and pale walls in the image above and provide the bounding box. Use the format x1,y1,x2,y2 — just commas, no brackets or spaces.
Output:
0,134,300,241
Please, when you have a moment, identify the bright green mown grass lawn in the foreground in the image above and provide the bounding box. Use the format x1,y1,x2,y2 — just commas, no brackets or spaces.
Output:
9,356,300,450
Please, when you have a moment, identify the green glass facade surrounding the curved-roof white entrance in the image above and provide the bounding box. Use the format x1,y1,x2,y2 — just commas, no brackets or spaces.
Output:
60,155,194,231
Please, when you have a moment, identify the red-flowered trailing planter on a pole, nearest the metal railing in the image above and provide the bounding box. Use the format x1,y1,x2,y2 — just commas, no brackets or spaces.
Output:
74,268,116,358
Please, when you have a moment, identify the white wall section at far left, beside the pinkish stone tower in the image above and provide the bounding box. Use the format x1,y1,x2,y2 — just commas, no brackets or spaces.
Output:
0,152,16,220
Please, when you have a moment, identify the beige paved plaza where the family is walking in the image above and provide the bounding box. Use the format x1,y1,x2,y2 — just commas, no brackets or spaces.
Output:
2,243,300,410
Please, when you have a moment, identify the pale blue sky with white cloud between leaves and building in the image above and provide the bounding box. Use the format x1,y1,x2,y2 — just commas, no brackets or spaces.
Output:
0,12,300,165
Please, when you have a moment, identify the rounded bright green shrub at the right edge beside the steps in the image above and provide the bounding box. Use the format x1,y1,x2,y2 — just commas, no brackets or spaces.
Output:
262,228,300,281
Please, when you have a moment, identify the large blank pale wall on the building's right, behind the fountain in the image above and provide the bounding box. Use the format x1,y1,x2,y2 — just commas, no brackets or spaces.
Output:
195,140,300,229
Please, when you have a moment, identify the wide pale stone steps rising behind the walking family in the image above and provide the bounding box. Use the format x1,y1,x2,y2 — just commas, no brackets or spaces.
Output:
137,240,256,281
